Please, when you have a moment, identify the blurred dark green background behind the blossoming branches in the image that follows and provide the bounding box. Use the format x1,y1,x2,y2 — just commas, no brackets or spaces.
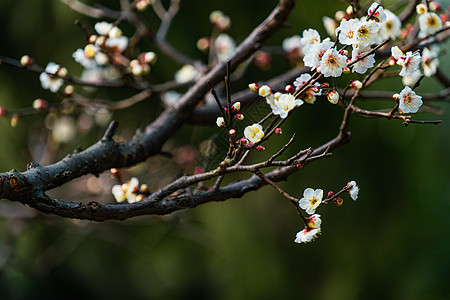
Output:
0,0,450,299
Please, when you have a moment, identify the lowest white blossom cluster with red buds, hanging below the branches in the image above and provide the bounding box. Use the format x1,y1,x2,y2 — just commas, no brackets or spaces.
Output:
294,180,359,243
